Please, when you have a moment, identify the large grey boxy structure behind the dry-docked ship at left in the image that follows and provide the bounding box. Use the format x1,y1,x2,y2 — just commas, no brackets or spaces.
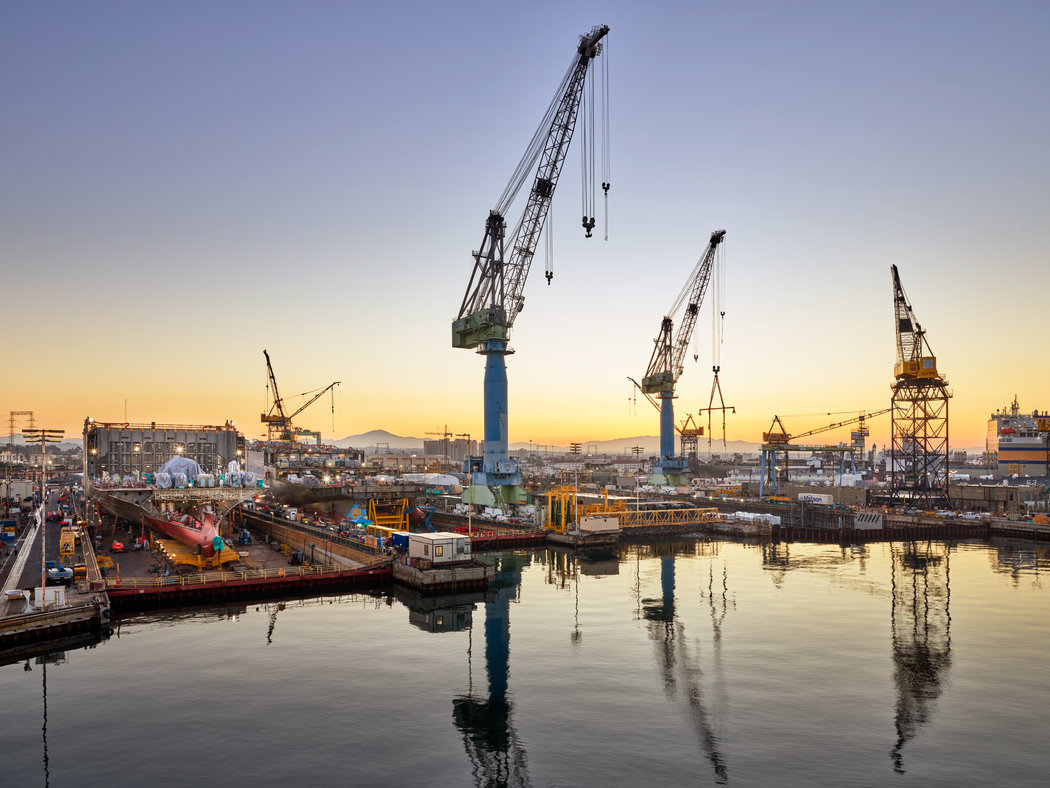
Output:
84,419,245,478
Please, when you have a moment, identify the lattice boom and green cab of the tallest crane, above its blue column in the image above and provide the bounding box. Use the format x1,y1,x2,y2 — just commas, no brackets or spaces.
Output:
453,25,609,348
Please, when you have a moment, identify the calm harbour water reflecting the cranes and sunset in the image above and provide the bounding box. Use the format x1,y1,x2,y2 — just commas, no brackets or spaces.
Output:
0,540,1050,788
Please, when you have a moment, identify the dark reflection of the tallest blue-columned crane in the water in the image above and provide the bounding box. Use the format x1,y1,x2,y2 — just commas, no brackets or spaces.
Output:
453,554,531,788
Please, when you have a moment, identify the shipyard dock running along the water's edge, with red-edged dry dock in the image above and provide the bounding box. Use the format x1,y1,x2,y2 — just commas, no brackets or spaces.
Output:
8,491,1050,661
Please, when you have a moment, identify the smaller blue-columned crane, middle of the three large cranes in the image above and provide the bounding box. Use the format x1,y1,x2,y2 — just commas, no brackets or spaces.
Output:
628,230,726,484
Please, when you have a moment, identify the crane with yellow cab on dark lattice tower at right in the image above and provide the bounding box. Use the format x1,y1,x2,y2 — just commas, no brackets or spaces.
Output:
889,266,951,509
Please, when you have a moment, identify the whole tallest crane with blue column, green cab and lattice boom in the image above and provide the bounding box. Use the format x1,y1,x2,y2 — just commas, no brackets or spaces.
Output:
453,25,609,503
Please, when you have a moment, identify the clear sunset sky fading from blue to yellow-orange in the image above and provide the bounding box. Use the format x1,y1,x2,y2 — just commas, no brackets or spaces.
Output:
0,0,1050,448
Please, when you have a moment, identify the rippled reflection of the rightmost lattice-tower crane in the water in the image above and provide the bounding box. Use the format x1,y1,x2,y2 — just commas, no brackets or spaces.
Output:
890,542,951,774
